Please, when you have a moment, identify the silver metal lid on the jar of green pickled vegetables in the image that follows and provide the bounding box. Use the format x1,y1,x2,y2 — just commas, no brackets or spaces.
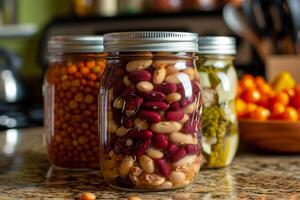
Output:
198,37,236,55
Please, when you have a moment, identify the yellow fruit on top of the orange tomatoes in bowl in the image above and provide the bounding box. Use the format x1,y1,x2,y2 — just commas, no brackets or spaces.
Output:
272,72,296,92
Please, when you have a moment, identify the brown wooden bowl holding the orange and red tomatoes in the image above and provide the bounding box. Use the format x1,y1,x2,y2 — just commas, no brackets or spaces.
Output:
239,119,300,153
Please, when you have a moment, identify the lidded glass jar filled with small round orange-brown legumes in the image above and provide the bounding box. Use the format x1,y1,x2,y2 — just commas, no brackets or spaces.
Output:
44,36,106,169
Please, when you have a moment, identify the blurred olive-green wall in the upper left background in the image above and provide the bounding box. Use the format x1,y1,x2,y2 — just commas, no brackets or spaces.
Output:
0,0,71,76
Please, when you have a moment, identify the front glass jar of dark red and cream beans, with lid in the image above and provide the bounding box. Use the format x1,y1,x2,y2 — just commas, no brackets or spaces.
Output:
100,32,202,191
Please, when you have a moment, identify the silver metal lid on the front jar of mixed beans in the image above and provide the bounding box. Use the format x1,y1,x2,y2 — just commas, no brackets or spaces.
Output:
104,31,198,52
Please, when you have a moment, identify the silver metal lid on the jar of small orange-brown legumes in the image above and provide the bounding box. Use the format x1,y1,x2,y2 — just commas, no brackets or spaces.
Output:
48,35,103,55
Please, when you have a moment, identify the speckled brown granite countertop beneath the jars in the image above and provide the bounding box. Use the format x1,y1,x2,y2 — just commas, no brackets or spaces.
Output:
0,128,300,200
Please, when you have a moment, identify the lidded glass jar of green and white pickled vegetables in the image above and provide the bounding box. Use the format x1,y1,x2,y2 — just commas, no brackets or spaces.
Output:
197,37,239,168
